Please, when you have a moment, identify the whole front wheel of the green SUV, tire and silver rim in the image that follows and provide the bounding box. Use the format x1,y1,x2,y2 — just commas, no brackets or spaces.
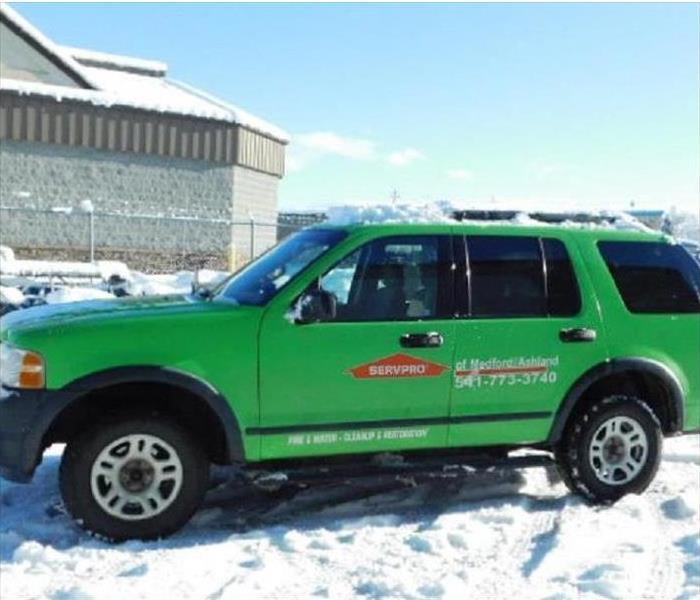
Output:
60,417,209,541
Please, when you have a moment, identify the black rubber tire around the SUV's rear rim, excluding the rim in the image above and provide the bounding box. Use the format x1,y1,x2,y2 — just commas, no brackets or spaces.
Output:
557,396,663,504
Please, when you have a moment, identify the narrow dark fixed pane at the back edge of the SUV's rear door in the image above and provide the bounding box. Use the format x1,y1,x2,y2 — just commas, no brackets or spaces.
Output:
542,238,581,317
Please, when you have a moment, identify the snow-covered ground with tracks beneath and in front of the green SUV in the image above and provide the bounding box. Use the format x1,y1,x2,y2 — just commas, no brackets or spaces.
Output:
0,436,700,600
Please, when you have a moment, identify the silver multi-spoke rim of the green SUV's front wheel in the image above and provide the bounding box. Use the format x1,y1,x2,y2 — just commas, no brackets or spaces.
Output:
90,434,182,521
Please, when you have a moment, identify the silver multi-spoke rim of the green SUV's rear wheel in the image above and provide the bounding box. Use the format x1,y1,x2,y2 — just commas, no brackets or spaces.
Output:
588,416,649,486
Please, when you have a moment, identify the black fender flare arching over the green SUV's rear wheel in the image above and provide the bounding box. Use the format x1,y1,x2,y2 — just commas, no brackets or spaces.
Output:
547,358,685,444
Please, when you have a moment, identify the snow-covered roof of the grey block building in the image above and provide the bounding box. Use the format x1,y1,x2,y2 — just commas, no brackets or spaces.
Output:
0,3,289,143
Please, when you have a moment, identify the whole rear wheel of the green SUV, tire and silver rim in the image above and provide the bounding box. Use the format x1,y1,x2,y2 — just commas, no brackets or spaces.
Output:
557,396,662,503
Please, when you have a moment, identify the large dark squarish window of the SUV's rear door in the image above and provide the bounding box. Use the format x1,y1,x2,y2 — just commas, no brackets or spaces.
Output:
467,236,547,317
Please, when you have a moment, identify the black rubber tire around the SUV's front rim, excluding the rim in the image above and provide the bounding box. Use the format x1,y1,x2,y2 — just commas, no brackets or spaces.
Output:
59,416,209,542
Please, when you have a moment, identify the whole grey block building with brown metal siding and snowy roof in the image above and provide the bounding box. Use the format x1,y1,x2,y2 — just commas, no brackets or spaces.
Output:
0,4,289,268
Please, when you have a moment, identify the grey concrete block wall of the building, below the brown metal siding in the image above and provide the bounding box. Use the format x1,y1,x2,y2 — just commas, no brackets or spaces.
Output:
0,140,279,267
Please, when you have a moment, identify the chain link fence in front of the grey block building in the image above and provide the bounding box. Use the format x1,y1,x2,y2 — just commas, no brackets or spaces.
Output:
0,206,324,273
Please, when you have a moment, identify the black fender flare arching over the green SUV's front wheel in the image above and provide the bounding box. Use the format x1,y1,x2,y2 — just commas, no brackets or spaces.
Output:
34,366,245,463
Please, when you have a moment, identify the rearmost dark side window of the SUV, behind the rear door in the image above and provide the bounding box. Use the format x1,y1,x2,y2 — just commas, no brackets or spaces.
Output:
598,242,700,313
